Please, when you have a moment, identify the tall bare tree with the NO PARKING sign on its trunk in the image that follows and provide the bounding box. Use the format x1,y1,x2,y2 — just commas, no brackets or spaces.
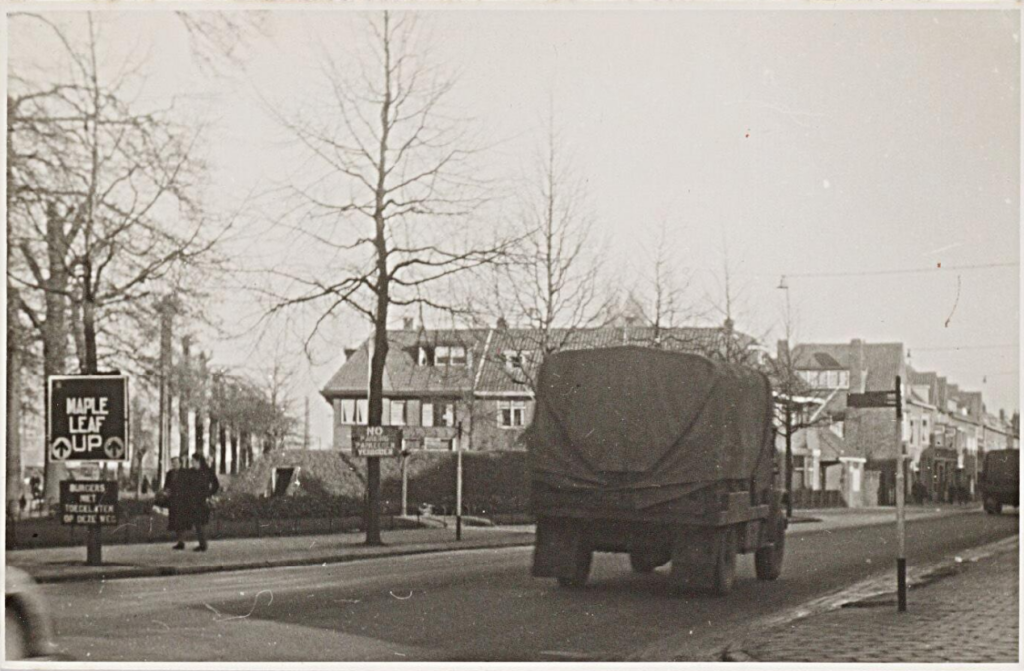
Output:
258,12,505,544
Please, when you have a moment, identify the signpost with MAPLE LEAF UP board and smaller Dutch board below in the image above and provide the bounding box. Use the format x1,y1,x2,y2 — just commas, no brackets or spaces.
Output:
46,375,129,565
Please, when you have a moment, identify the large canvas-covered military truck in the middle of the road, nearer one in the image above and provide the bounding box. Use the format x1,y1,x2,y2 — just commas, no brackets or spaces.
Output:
525,346,786,594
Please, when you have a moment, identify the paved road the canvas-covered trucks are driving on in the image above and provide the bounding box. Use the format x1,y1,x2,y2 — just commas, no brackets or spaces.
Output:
44,512,1019,662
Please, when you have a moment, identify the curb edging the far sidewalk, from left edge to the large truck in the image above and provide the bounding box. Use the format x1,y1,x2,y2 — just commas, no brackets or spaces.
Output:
27,538,534,585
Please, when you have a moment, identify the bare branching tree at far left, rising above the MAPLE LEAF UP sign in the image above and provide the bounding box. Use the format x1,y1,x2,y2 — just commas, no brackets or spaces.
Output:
7,13,226,496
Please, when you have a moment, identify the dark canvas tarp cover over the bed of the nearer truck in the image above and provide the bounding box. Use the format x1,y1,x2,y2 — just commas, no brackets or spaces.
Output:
526,347,774,506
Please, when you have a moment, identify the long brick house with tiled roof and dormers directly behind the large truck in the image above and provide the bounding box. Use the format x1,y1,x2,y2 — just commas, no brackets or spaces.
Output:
321,322,763,451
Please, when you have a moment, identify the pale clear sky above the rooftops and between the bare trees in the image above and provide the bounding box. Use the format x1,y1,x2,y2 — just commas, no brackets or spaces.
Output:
9,5,1021,456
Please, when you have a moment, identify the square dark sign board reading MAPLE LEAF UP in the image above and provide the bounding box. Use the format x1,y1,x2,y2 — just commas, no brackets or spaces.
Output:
46,375,128,461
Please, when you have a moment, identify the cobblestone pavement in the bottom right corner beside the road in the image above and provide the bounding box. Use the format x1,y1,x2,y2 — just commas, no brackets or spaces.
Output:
731,545,1020,663
